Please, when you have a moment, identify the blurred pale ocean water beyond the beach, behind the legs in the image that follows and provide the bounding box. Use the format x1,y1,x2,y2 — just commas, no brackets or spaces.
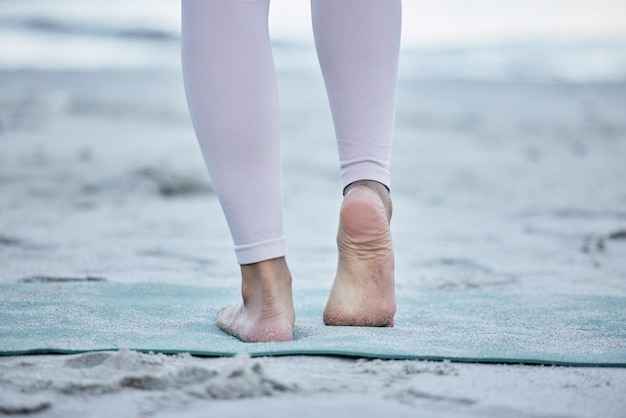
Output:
0,0,626,83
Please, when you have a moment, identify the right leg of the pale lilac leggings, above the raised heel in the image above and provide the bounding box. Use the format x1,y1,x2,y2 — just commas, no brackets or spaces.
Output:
311,0,402,188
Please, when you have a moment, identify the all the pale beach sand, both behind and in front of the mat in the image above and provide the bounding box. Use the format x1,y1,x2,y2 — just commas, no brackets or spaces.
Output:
0,63,626,417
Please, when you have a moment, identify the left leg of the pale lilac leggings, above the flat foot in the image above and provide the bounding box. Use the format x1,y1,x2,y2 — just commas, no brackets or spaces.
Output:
182,0,286,264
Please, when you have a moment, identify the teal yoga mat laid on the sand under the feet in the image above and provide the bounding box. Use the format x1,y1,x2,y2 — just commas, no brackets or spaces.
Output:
0,282,626,367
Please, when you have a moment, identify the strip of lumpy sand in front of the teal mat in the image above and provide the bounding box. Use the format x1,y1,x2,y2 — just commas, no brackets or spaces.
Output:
0,350,626,417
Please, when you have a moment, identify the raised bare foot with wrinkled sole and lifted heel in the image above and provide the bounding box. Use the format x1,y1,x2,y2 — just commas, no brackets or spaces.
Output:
324,181,396,327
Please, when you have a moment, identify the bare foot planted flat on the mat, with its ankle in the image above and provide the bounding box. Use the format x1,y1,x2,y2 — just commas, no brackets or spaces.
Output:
217,257,295,342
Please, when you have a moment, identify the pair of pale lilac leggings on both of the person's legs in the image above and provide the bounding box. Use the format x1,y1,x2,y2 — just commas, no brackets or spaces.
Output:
182,0,401,264
